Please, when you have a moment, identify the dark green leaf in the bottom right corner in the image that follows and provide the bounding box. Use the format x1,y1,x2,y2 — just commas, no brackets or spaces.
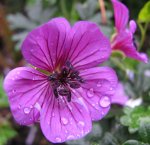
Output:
139,122,150,143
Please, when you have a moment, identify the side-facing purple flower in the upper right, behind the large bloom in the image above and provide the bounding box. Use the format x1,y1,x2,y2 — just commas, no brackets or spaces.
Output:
111,0,148,63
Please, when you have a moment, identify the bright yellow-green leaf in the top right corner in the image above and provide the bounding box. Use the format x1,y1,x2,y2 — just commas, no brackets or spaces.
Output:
138,1,150,22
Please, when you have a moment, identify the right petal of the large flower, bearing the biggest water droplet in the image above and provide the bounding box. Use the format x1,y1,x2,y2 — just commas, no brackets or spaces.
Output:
80,67,117,120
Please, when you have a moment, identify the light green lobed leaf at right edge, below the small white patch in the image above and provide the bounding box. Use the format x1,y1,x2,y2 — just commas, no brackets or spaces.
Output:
120,106,150,133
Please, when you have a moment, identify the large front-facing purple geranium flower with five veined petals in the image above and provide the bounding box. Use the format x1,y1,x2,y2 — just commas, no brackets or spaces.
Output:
4,18,117,142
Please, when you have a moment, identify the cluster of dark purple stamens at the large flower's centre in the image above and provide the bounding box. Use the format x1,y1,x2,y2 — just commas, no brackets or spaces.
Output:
48,61,84,102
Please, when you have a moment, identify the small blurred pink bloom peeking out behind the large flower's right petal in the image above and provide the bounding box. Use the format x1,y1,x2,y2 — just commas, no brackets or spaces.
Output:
111,83,129,105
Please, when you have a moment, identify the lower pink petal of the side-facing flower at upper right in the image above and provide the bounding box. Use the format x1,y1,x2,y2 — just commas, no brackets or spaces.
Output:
112,30,148,63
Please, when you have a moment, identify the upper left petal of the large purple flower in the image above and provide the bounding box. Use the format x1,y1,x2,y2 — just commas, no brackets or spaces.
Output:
22,18,70,71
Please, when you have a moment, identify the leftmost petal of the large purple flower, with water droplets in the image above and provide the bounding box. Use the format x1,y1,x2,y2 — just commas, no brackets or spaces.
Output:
4,67,47,125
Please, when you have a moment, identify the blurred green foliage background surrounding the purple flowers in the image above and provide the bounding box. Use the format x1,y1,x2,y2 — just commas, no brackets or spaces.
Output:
0,0,150,145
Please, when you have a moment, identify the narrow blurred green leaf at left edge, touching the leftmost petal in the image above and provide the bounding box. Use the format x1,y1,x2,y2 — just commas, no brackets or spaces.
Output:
0,77,9,107
